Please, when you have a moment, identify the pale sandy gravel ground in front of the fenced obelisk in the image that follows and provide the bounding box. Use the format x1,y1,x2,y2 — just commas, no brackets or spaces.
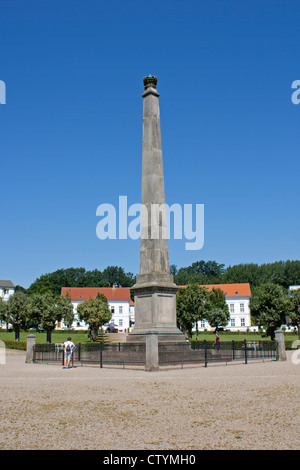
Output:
0,351,300,450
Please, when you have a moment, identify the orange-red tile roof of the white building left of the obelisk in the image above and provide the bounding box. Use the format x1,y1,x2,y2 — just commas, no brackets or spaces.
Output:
61,287,130,302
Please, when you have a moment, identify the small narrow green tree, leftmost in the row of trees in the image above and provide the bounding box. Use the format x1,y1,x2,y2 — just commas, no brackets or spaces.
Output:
7,291,29,341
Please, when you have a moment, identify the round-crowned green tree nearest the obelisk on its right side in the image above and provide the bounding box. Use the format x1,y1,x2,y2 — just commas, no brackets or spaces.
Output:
176,284,208,337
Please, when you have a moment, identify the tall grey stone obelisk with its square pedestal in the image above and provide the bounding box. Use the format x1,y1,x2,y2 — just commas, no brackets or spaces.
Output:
127,75,185,342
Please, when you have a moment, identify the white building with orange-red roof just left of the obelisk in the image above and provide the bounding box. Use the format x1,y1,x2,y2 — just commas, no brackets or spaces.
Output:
59,287,134,332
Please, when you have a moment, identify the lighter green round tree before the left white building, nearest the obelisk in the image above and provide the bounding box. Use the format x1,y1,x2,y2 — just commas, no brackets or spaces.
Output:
77,294,111,341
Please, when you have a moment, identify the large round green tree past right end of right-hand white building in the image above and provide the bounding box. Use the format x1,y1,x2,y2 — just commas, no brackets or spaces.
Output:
250,283,292,339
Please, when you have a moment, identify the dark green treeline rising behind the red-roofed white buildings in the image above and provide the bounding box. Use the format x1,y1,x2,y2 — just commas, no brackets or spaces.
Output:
16,260,300,295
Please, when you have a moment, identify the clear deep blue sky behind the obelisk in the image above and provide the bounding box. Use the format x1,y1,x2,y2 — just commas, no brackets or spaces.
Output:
0,0,300,287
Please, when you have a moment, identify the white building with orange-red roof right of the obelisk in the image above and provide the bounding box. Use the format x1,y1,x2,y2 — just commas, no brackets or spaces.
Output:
180,283,255,331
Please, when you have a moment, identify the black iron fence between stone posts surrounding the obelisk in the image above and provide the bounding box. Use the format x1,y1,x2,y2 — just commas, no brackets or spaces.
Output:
33,341,277,368
